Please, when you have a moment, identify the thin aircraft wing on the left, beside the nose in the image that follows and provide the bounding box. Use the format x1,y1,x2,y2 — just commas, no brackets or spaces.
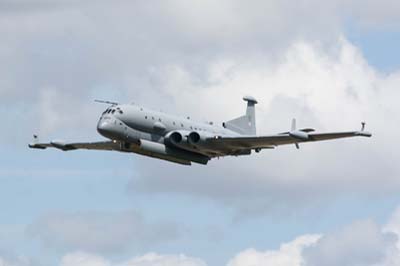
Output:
29,136,120,151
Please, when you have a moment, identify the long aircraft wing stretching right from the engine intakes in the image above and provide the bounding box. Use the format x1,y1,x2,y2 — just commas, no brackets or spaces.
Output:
207,127,372,150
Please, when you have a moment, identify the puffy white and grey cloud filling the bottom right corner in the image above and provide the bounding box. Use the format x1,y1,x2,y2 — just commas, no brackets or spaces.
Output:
228,213,400,266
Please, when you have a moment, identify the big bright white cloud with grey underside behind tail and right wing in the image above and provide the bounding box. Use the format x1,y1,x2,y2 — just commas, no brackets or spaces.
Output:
127,37,400,217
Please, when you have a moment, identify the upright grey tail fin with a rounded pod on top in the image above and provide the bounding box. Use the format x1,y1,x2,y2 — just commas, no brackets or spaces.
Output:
223,96,257,135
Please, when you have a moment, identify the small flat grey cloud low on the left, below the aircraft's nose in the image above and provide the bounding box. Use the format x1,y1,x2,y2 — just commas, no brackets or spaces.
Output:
27,211,180,254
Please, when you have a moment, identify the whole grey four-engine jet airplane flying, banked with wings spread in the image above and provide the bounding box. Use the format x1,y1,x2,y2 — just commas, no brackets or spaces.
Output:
29,96,372,165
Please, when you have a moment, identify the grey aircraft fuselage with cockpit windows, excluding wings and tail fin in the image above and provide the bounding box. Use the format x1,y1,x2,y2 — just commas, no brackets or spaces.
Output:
97,104,244,163
